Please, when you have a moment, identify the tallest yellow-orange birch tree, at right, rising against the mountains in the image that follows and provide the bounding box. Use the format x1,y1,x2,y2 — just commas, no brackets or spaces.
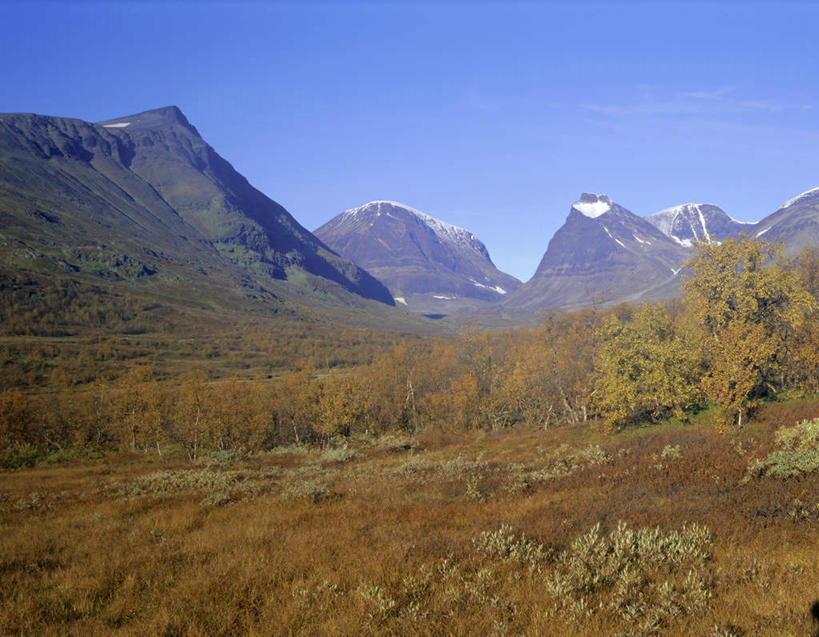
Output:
683,235,815,427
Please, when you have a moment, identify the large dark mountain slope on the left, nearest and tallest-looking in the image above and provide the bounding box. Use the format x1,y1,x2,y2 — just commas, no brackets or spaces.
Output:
0,106,393,316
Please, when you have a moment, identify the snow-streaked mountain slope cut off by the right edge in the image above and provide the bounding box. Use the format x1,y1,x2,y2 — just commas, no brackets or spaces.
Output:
754,188,819,254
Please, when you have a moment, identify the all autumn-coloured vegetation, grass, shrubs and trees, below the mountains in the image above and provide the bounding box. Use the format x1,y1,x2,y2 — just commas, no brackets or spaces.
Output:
0,239,819,636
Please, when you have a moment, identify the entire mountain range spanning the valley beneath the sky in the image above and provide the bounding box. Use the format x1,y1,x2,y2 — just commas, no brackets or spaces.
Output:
0,106,819,324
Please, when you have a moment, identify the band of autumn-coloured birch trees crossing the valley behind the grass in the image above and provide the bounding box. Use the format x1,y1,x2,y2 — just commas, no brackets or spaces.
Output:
0,237,819,460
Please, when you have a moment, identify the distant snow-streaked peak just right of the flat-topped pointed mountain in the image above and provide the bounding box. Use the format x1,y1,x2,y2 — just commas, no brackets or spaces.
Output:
645,203,754,247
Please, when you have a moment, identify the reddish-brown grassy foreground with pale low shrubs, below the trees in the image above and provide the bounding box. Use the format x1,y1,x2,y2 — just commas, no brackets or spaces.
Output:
0,401,819,636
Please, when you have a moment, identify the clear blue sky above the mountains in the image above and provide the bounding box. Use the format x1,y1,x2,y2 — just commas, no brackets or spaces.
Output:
0,0,819,280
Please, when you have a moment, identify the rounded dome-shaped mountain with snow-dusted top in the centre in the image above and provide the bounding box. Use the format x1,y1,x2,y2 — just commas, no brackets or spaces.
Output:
315,201,520,314
